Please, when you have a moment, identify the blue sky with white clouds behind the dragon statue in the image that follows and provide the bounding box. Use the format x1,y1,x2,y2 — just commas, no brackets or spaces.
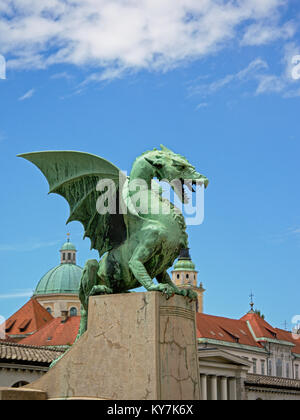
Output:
0,0,300,328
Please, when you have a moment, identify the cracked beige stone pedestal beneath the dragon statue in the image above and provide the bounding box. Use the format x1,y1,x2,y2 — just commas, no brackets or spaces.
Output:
5,292,200,400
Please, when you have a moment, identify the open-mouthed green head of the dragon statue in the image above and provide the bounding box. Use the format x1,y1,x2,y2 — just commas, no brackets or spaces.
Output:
144,145,209,203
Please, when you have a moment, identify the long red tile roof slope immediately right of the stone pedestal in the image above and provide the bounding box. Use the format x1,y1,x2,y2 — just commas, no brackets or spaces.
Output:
197,313,262,347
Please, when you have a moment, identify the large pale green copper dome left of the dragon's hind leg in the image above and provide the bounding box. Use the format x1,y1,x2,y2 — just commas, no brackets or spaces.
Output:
33,264,83,296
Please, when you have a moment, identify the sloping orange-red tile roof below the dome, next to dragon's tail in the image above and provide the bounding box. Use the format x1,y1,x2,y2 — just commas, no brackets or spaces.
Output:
20,316,80,346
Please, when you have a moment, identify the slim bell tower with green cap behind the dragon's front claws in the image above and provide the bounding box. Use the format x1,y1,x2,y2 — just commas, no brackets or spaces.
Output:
172,248,205,313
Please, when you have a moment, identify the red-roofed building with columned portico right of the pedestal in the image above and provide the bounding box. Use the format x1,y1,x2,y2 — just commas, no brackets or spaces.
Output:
196,310,300,400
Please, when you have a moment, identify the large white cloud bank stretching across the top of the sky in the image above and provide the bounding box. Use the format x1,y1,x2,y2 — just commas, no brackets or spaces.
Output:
0,0,294,80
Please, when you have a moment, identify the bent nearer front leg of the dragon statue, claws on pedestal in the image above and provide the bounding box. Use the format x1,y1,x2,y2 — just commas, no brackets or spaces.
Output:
128,241,175,298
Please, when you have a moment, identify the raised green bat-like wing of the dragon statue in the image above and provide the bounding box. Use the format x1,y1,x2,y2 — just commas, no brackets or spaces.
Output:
18,151,127,257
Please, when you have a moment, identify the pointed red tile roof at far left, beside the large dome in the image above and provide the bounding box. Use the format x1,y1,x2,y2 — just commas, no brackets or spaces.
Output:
1,298,53,337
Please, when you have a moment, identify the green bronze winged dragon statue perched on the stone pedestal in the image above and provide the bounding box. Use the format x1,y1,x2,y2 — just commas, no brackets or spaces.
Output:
19,146,208,339
